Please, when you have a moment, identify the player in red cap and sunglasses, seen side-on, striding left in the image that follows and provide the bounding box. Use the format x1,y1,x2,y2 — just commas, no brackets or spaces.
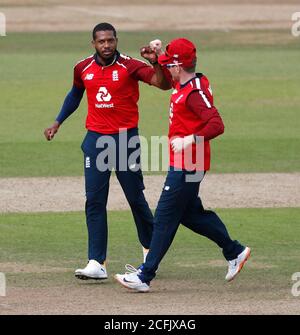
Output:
115,38,250,292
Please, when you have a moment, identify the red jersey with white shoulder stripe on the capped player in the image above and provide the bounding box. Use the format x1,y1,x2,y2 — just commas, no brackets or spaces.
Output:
169,74,224,171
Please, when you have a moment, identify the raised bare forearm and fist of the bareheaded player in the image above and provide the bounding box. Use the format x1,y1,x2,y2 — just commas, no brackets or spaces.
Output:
140,46,172,90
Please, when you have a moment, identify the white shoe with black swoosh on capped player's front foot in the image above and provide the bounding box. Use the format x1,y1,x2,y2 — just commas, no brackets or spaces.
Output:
115,264,150,292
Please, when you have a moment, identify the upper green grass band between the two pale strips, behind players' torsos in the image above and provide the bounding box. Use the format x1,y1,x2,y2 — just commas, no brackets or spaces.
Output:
0,31,300,177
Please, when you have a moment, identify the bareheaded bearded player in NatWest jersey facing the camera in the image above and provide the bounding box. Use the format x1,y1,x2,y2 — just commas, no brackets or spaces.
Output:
44,23,172,280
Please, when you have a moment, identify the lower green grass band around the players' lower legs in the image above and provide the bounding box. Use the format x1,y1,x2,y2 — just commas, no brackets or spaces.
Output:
0,208,300,299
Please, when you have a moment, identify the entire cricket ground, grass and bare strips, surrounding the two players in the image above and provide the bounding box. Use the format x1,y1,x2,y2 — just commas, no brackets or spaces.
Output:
0,0,300,315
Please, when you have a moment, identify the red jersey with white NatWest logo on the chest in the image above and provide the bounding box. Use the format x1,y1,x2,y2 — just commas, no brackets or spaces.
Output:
73,52,155,134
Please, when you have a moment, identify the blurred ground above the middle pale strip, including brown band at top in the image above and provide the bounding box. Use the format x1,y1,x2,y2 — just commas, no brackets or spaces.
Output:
0,0,300,177
